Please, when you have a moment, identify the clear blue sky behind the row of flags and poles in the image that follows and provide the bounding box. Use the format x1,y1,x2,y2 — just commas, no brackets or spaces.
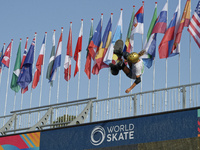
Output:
0,0,200,116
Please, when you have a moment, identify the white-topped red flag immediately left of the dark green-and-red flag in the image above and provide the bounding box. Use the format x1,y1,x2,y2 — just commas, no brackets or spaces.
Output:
74,19,83,77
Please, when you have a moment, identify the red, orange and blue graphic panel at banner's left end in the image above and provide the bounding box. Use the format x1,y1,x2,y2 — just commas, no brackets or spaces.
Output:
0,132,40,150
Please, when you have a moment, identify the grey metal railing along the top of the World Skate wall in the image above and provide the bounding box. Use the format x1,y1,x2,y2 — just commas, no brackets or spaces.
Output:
0,83,200,134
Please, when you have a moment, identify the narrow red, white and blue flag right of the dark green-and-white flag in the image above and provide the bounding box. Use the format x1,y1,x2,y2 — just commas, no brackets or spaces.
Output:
49,27,63,82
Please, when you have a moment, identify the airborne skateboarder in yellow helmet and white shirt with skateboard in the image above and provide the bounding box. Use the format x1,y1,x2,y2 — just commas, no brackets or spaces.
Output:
109,40,145,93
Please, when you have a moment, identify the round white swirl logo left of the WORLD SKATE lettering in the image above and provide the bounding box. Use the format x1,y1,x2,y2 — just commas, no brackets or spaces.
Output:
91,126,106,146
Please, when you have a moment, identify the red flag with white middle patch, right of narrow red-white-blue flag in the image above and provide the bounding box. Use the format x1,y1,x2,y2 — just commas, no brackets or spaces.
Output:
64,22,72,81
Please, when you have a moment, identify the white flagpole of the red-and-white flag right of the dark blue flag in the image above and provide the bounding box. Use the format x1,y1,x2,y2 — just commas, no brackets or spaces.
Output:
38,32,47,121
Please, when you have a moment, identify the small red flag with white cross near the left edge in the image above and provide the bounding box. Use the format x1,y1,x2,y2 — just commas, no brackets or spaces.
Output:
1,40,13,68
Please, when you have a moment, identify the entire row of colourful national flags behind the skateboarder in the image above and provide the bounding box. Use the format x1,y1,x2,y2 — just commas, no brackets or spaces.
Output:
0,0,200,93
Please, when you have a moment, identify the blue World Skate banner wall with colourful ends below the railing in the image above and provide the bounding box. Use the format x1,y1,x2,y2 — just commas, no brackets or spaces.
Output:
0,108,200,150
